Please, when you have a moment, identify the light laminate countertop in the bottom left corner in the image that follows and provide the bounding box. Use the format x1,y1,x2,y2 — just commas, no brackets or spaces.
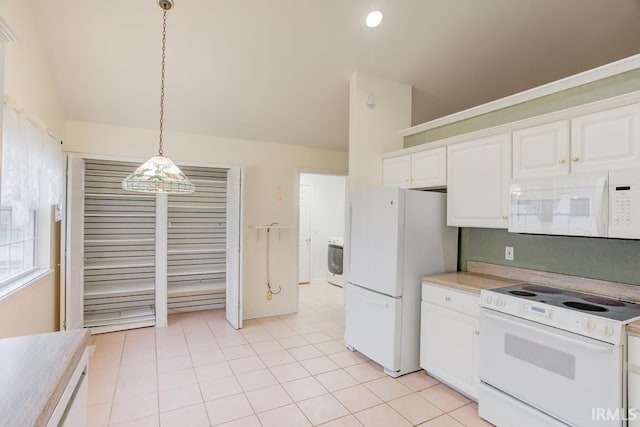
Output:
0,329,90,426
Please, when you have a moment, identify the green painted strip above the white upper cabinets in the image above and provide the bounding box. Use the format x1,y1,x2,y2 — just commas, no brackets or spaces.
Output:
404,69,640,148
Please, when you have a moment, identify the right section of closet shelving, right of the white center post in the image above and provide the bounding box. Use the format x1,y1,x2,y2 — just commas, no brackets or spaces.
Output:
167,167,227,313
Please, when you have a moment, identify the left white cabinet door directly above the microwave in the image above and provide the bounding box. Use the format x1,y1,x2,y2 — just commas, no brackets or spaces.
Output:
513,120,571,178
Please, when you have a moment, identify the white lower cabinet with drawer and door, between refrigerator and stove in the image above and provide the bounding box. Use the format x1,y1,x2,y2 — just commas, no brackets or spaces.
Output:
420,283,480,400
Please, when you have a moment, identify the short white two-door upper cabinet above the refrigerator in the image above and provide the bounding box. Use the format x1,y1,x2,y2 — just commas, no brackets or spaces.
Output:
382,147,447,188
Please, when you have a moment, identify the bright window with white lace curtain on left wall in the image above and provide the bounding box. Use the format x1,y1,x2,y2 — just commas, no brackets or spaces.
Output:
0,105,64,297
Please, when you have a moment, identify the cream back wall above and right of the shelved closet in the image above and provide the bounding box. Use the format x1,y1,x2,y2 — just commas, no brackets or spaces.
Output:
64,121,347,318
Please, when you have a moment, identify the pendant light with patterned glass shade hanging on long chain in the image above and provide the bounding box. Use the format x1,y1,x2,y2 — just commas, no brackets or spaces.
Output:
122,0,196,194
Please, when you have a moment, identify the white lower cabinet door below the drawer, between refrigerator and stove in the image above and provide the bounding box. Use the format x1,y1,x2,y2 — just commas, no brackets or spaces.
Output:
420,302,480,399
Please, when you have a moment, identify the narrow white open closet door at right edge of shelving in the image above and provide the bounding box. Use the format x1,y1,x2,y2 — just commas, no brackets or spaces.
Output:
225,167,242,329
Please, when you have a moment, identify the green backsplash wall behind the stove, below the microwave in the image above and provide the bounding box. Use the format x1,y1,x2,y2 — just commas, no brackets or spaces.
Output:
460,228,640,285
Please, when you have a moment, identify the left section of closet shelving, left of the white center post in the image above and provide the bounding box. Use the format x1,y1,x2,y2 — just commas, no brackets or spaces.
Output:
83,160,156,329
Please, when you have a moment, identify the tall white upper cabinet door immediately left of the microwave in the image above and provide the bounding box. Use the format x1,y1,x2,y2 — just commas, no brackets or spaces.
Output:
447,134,511,228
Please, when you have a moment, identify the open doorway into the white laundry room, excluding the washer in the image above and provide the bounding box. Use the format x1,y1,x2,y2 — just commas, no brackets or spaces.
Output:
298,173,347,286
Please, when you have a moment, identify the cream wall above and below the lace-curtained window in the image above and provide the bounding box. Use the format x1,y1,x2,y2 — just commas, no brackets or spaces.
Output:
0,0,64,337
